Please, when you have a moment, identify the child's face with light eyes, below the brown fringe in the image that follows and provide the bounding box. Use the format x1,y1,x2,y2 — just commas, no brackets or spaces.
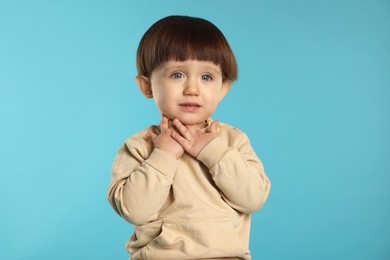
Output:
141,60,231,126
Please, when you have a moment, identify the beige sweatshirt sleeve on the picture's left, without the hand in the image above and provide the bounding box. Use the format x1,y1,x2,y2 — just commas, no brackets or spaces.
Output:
107,140,178,225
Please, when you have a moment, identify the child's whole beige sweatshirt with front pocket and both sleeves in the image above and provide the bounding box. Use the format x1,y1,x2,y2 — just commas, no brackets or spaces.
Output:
107,119,271,260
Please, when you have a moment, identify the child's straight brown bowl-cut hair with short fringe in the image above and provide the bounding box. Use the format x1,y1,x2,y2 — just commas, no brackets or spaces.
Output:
137,16,238,81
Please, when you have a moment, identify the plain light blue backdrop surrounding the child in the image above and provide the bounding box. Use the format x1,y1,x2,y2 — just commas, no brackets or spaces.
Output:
0,0,390,260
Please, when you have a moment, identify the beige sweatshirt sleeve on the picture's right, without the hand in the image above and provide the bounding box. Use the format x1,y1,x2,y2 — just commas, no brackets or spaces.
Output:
198,131,271,213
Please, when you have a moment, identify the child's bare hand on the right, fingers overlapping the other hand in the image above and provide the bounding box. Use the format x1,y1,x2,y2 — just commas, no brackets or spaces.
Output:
171,119,218,158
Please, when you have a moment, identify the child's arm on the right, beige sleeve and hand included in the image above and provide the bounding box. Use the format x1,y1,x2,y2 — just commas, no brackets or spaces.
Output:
172,119,271,213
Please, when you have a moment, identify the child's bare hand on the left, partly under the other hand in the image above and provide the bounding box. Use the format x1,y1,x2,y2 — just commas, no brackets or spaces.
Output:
147,115,184,159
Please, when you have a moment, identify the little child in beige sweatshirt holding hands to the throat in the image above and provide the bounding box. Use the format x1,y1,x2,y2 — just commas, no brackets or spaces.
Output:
107,16,271,260
